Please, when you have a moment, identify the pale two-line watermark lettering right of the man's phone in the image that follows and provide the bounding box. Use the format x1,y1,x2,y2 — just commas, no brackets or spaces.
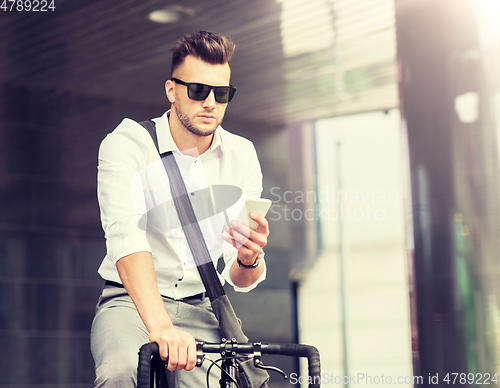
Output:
269,187,399,224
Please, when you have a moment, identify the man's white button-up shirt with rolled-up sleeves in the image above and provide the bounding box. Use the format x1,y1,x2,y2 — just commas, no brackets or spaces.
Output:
97,112,266,299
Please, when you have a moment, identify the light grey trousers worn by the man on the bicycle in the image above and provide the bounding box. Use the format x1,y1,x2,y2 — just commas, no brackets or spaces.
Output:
90,286,220,388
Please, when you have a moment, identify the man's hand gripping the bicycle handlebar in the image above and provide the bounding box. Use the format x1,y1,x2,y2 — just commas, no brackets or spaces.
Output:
149,326,196,371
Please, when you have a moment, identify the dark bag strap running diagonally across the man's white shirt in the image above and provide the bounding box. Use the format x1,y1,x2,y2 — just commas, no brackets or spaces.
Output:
140,121,225,302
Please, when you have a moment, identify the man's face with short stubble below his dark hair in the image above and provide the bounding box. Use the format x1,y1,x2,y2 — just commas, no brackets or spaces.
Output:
167,55,231,136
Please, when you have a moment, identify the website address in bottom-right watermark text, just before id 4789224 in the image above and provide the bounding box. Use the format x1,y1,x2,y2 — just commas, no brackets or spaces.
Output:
289,373,424,386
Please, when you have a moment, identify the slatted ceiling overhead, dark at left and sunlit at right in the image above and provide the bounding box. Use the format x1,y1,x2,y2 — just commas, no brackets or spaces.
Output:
0,0,397,127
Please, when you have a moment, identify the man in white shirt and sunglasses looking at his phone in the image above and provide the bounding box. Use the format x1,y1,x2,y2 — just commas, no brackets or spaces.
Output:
91,31,269,387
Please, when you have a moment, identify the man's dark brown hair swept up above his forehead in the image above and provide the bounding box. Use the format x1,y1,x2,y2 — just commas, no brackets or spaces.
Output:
171,31,235,74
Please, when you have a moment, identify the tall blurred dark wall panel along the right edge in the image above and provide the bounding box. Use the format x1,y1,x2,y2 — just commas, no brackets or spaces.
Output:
396,0,500,378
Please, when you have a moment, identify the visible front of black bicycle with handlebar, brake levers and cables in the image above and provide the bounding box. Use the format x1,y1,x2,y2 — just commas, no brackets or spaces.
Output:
137,338,321,388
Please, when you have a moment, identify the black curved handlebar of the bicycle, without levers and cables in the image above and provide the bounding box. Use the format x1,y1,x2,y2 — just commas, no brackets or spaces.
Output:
137,342,321,388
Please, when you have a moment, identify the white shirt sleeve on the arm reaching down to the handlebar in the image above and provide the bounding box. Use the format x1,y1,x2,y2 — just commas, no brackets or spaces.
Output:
97,127,151,264
